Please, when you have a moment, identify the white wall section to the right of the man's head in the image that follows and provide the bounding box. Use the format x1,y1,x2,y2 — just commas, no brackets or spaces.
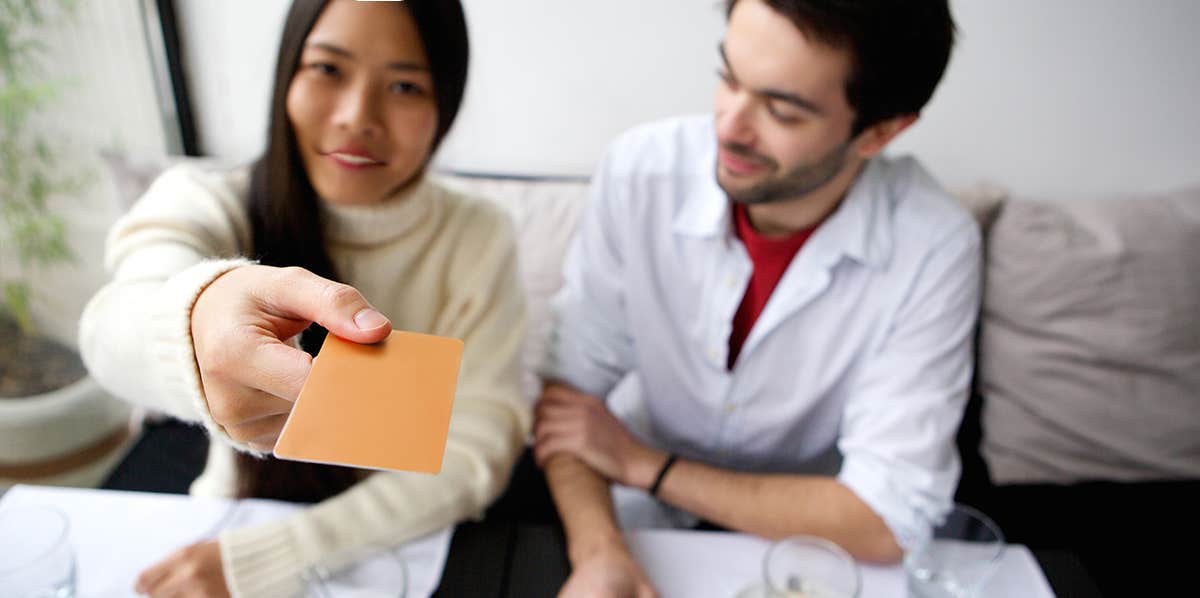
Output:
895,0,1200,198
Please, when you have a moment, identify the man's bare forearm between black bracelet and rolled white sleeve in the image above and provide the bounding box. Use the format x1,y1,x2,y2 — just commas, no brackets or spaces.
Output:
658,460,902,563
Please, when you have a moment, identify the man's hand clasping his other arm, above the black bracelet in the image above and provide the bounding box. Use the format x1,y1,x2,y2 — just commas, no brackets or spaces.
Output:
534,384,666,489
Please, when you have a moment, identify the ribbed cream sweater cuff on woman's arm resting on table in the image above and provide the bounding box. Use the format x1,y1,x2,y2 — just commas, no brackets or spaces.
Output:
220,520,304,598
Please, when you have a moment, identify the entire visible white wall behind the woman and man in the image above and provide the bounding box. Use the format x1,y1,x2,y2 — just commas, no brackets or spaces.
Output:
179,0,1200,198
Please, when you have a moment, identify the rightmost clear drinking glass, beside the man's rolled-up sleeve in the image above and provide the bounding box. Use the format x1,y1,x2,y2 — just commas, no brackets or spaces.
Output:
904,504,1004,598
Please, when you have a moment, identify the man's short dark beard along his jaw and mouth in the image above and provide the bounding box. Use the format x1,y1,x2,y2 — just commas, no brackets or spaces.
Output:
716,140,850,205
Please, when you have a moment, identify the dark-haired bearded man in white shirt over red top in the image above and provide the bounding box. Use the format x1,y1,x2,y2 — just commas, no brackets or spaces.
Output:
535,0,982,596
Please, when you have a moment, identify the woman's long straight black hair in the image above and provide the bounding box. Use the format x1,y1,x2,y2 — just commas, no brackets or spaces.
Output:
238,0,469,502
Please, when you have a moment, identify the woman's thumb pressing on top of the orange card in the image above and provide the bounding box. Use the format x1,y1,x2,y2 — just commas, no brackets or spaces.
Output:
259,268,391,343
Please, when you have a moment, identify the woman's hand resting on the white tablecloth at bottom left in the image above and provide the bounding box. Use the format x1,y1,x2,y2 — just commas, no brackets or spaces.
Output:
134,540,229,598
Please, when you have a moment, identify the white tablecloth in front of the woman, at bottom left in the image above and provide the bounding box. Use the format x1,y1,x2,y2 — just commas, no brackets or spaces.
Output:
0,486,452,598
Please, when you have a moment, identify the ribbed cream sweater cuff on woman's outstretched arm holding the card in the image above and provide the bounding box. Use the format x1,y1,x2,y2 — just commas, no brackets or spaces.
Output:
150,254,262,455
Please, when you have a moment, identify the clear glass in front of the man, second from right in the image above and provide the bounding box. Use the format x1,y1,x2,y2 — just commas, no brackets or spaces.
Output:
762,536,862,598
